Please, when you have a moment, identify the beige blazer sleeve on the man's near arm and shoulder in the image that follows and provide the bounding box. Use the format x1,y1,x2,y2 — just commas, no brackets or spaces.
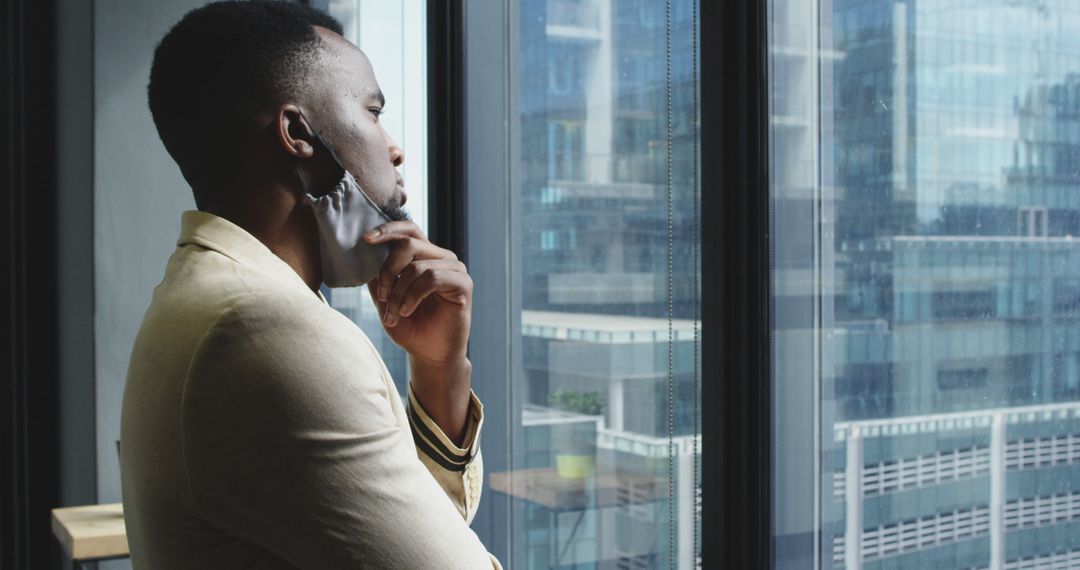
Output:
180,295,500,569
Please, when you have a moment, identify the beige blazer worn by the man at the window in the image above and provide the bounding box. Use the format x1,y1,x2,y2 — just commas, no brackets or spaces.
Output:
120,212,500,570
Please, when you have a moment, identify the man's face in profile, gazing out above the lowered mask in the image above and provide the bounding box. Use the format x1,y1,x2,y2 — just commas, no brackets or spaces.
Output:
310,27,406,217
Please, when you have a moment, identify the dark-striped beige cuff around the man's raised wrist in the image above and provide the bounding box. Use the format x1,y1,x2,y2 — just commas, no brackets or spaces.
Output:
407,383,484,472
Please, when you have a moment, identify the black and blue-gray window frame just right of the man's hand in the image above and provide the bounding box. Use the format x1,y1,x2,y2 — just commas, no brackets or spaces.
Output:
428,0,522,560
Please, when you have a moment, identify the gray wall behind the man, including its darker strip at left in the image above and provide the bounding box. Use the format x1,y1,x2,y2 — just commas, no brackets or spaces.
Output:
57,0,203,568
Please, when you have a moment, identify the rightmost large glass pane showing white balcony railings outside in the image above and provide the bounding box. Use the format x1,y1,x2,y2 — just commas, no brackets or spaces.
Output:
769,0,1080,570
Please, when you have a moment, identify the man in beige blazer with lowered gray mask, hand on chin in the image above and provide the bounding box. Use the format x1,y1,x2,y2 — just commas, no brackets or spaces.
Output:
120,1,499,569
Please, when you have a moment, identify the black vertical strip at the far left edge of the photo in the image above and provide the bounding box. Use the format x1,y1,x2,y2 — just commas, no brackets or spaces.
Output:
0,0,60,569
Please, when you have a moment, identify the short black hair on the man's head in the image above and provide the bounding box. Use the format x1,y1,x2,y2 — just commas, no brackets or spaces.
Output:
147,0,342,203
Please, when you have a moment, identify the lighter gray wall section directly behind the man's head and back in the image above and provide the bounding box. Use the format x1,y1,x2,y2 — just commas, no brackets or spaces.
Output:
93,0,202,568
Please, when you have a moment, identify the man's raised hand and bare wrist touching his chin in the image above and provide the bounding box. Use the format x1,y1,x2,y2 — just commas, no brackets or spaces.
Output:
364,221,473,444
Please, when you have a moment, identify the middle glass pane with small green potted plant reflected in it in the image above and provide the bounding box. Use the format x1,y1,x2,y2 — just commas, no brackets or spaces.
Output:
489,0,700,569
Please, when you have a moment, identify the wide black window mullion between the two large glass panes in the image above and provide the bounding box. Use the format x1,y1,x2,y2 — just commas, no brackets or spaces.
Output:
701,0,772,569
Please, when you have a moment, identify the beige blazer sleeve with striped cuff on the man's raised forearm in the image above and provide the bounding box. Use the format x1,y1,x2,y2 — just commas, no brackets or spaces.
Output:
406,384,484,524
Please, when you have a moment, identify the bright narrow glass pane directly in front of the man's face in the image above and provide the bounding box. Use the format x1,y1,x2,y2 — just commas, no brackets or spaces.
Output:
311,0,428,394
